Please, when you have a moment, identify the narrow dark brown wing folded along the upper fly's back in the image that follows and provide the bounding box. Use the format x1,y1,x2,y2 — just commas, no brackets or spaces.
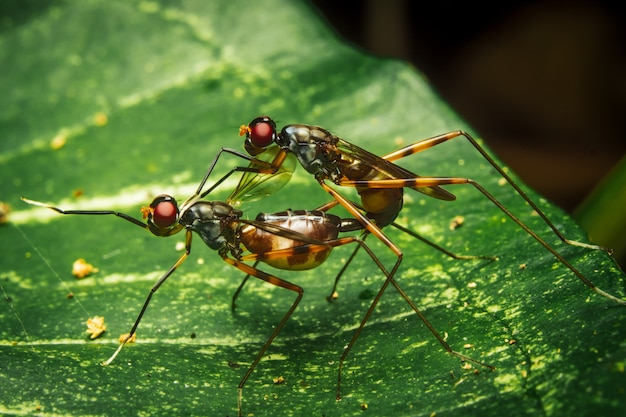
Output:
337,139,456,201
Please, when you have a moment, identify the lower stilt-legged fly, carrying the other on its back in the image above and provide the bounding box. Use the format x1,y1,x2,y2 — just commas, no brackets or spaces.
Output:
22,151,494,416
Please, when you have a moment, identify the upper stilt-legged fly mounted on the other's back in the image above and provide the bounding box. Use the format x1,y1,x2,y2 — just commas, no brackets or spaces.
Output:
239,116,626,305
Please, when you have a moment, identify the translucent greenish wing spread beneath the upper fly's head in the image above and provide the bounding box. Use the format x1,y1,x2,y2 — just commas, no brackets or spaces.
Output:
226,145,297,207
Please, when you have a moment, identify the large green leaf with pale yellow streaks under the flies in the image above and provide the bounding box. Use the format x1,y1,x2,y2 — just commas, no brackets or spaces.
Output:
0,0,626,417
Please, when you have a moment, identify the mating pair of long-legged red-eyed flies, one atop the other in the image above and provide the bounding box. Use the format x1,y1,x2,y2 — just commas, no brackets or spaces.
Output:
24,117,626,415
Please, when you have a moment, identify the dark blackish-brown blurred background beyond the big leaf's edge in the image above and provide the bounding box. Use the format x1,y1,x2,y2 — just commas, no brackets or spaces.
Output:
312,0,626,212
